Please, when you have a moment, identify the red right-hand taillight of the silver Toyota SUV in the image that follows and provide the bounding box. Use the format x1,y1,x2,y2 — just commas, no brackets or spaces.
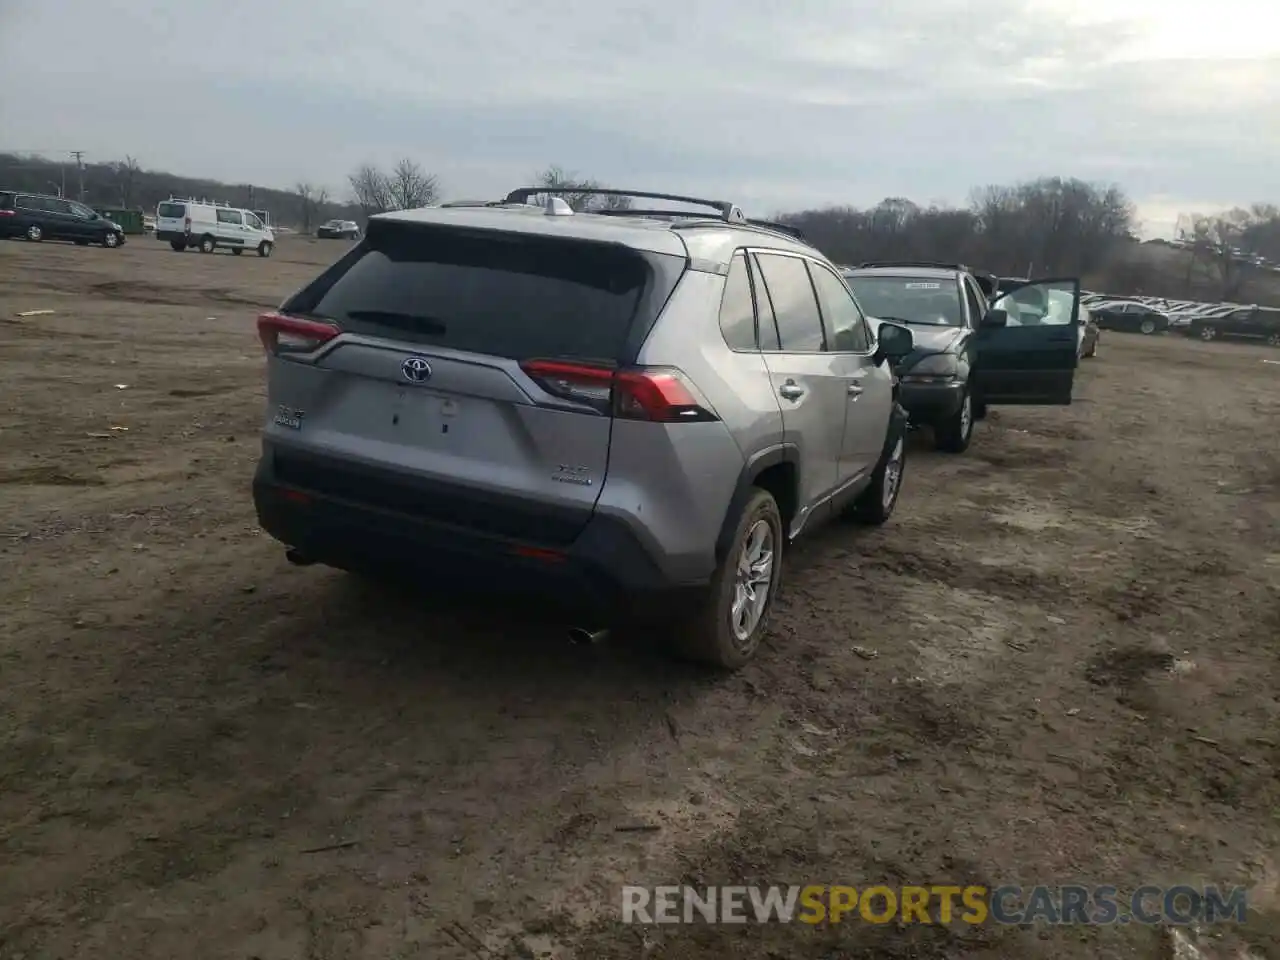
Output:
520,360,719,424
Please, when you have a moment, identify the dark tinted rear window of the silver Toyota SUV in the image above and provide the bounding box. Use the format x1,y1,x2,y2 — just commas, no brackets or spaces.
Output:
285,224,678,361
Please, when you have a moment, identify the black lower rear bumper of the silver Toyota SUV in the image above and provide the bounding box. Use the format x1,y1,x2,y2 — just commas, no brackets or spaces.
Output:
253,454,707,621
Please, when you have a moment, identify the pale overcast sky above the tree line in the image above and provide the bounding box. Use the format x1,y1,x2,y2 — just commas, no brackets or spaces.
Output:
0,0,1280,233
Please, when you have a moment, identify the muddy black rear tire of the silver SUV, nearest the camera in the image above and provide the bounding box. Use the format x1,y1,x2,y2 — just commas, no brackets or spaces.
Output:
672,489,785,669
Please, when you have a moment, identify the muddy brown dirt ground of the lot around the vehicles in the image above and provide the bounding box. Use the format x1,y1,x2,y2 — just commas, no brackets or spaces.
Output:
0,239,1280,960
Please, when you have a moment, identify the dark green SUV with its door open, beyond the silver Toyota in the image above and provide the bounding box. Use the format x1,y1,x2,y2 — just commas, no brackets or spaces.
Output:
842,261,1080,453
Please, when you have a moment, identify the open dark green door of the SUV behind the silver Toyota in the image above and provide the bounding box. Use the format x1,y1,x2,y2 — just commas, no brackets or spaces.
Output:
973,278,1080,404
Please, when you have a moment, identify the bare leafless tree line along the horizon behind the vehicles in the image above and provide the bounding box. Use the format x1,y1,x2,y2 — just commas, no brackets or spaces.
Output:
0,154,1280,301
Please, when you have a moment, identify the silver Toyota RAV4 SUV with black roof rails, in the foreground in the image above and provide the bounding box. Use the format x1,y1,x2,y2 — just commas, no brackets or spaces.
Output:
253,188,911,668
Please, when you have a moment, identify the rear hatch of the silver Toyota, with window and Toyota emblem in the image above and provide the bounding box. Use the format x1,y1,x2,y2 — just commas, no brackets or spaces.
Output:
259,220,686,544
